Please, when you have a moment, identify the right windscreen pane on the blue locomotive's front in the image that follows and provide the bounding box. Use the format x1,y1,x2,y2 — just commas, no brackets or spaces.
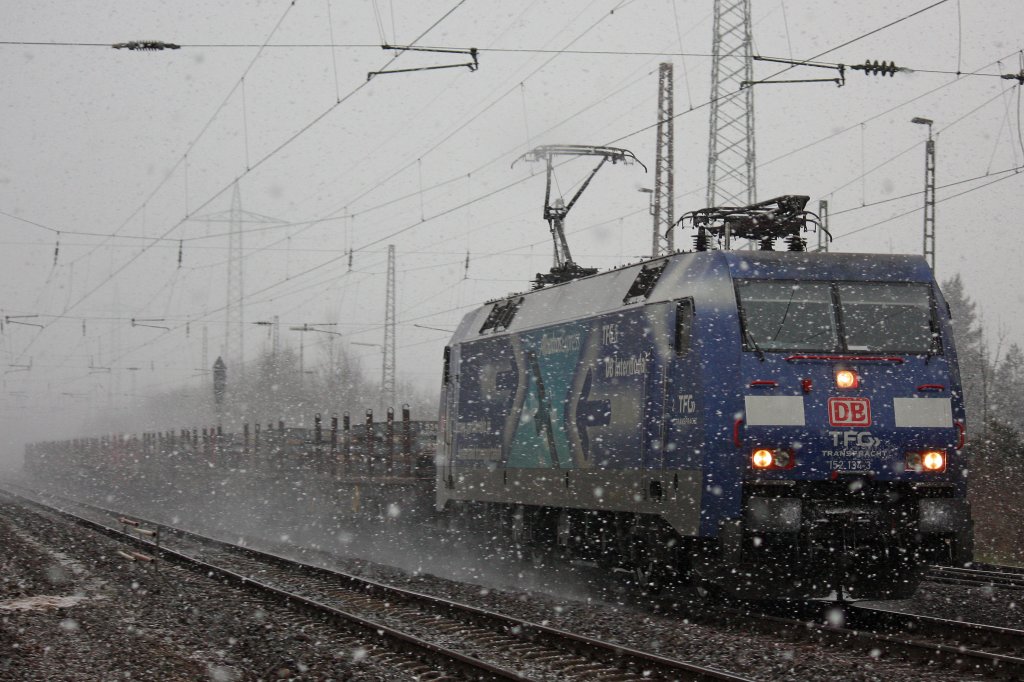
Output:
837,282,938,353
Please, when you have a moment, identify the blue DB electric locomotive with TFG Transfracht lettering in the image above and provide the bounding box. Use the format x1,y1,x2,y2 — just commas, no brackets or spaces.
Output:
437,197,972,598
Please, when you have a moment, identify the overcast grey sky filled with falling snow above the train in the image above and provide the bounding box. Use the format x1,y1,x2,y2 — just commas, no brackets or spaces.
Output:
0,0,1024,441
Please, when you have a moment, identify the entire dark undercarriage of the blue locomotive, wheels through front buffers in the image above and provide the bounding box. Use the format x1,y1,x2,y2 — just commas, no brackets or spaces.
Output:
449,479,972,599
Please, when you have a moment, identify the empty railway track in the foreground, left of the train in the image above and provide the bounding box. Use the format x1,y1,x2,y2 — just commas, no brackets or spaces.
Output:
2,483,746,682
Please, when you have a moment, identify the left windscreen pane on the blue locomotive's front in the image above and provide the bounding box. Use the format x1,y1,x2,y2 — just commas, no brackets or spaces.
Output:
736,280,839,351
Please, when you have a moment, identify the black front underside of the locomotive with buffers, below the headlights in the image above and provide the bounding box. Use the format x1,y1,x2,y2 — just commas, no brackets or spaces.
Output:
710,477,972,599
